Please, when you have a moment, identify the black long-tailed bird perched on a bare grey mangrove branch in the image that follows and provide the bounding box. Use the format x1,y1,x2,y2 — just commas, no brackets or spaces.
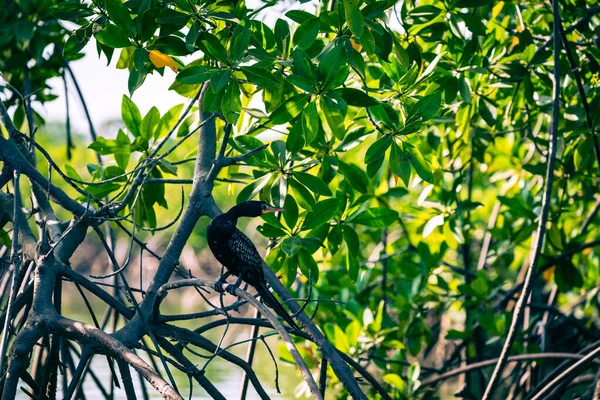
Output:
206,201,298,329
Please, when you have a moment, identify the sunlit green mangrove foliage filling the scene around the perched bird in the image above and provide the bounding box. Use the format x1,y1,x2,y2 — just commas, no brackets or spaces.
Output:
0,0,600,398
